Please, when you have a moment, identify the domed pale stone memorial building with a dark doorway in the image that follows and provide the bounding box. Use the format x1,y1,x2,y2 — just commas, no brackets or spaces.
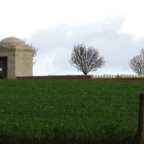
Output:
0,37,33,79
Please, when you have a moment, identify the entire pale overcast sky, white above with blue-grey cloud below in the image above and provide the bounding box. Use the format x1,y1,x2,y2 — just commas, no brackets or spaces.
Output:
0,0,144,75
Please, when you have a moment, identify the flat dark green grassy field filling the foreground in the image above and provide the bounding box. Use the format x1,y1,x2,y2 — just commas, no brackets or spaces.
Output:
0,80,141,144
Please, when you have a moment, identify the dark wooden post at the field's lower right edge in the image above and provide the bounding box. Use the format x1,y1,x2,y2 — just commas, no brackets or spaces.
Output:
138,91,144,144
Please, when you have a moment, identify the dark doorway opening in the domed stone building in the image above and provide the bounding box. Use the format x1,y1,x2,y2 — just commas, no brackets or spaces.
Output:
0,57,7,79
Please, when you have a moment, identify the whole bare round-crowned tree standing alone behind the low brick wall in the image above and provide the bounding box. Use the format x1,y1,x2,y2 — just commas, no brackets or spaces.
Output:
69,44,105,75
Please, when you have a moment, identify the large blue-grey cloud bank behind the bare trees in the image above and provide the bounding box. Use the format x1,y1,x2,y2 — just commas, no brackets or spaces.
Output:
26,17,144,75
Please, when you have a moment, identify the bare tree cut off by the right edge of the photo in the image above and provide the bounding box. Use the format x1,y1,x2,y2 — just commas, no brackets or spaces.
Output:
129,49,144,75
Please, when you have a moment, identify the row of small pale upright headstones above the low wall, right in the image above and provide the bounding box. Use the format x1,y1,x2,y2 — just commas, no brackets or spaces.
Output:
92,74,144,78
